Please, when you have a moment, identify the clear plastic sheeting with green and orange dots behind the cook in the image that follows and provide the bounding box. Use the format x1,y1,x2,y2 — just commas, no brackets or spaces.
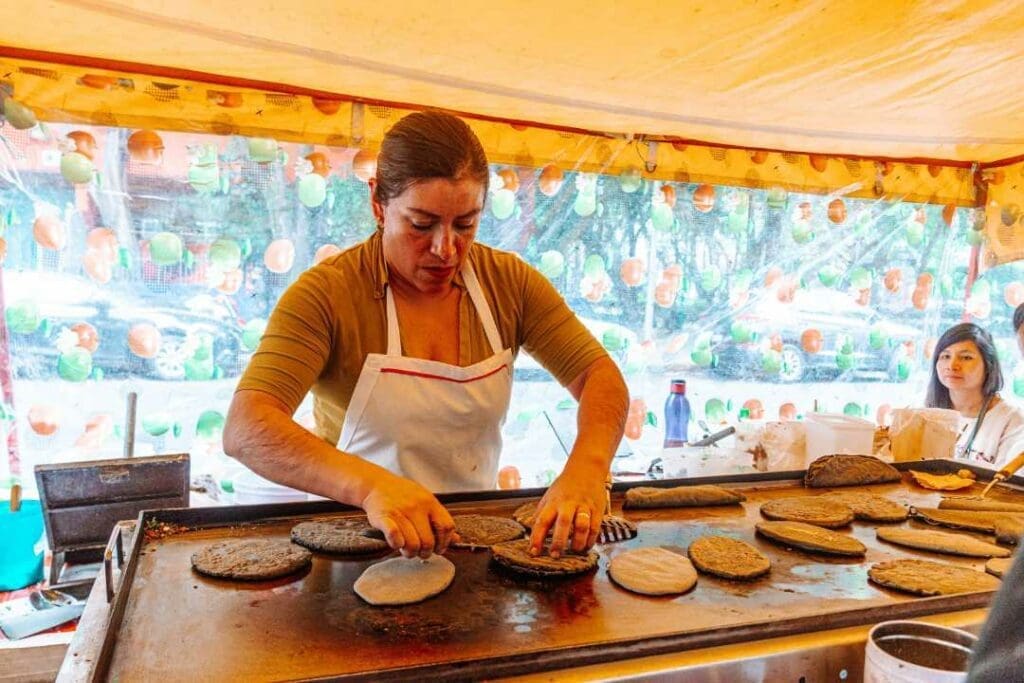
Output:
6,117,1024,485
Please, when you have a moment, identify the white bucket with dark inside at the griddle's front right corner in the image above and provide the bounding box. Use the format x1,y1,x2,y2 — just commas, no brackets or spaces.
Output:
864,622,978,683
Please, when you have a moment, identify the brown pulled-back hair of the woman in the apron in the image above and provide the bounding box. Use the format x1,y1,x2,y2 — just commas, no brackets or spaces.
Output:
374,110,490,204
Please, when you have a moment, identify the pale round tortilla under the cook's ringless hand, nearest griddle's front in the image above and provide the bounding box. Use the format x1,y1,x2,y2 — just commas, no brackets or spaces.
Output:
352,553,455,605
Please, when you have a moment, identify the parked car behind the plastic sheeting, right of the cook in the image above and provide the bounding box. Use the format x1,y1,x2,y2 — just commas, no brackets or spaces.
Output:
710,290,928,382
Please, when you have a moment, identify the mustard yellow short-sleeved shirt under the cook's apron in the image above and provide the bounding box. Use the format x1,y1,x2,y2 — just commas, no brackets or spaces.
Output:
236,232,607,443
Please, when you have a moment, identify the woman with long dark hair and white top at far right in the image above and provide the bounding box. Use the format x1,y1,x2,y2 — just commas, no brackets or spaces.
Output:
926,323,1024,469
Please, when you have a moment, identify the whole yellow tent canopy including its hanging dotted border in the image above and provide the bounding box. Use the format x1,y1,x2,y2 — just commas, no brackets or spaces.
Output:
0,0,1024,259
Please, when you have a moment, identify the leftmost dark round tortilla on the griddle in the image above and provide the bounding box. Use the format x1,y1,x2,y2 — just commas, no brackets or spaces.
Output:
191,539,312,581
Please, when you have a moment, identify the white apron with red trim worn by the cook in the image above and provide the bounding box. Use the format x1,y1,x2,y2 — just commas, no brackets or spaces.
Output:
338,262,512,493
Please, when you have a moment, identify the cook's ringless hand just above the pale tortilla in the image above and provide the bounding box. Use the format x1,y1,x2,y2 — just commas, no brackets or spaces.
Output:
360,472,455,559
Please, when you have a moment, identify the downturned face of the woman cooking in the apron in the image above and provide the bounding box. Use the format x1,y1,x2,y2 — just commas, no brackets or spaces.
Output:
370,178,483,295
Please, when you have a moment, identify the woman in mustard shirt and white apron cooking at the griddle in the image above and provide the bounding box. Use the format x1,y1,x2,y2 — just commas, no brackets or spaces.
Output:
224,112,629,557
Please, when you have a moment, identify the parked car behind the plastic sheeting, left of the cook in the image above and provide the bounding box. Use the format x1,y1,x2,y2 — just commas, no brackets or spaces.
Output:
3,270,248,380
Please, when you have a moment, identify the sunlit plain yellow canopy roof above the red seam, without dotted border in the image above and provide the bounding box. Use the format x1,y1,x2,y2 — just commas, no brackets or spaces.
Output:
0,0,1024,163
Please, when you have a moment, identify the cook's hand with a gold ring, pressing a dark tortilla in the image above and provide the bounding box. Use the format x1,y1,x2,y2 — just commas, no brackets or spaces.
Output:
529,467,606,557
